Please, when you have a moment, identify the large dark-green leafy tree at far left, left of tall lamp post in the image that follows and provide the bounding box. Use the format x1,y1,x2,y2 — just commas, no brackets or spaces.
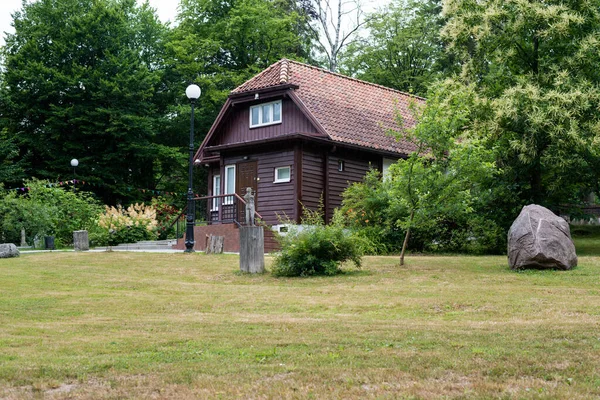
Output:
0,0,173,203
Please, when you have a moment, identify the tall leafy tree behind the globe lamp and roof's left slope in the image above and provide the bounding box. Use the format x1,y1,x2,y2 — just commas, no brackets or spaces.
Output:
161,0,312,198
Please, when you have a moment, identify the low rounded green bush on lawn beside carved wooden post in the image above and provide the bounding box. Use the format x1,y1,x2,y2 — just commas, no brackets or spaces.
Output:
272,209,363,276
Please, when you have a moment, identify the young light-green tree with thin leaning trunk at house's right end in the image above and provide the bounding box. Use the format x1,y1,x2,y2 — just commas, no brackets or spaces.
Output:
390,81,494,265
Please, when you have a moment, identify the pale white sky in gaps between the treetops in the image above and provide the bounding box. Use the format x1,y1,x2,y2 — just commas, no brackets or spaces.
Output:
0,0,390,46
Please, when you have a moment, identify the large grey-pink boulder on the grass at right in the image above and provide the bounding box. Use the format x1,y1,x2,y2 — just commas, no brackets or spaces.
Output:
508,204,577,270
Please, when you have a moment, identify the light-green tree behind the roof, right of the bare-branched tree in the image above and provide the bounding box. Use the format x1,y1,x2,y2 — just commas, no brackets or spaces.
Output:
342,0,454,96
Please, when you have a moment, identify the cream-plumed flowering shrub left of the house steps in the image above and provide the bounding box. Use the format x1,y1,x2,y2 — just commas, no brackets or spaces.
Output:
98,203,158,246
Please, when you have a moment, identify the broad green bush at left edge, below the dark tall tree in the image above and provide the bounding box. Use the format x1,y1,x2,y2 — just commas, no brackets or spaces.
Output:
0,179,102,245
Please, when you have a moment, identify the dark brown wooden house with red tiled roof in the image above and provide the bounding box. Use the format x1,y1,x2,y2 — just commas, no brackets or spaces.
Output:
177,59,424,251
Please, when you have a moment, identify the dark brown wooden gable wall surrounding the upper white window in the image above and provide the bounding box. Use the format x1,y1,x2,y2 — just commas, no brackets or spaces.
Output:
210,99,317,146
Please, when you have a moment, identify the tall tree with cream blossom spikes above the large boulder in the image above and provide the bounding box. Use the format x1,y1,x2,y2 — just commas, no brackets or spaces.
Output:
443,0,600,209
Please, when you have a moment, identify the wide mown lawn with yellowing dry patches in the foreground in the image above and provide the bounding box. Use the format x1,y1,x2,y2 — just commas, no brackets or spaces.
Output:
0,248,600,399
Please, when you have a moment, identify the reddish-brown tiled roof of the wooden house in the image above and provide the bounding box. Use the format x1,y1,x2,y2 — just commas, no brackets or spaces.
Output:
231,59,425,154
